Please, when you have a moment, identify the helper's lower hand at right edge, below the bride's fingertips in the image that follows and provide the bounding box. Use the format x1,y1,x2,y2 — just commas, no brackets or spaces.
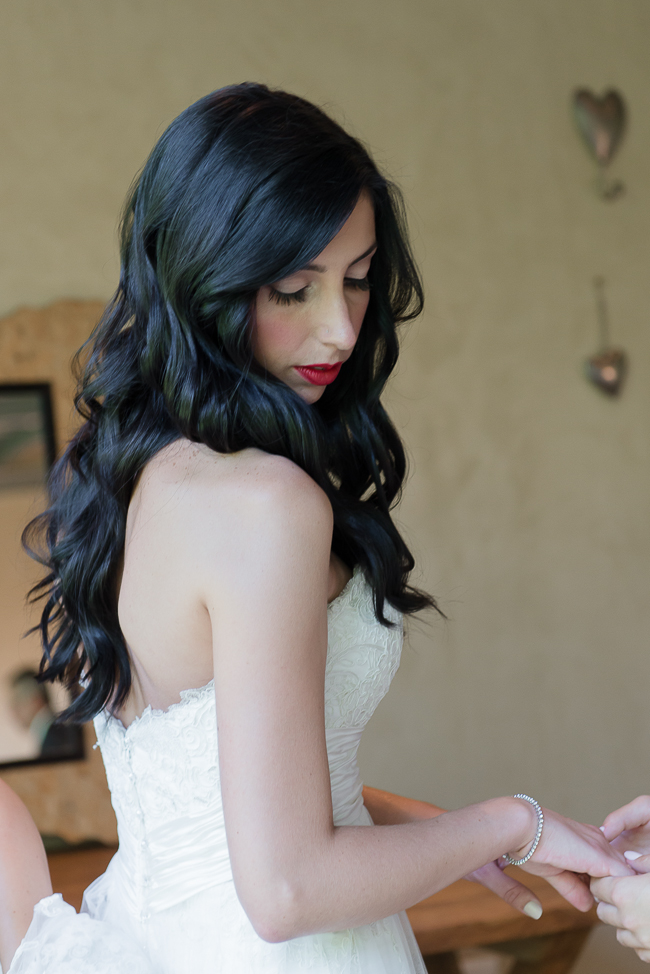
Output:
591,856,650,964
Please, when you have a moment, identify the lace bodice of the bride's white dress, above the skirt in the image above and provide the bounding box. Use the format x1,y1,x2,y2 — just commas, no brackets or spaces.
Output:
95,568,402,917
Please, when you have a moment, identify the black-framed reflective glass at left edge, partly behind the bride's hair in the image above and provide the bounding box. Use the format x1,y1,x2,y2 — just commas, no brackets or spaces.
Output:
0,383,84,769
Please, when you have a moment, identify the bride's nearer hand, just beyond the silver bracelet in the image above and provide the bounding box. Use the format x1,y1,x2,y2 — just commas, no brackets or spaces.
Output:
510,808,634,912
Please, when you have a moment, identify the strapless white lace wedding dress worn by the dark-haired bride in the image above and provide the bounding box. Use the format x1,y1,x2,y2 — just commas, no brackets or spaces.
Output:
8,569,425,974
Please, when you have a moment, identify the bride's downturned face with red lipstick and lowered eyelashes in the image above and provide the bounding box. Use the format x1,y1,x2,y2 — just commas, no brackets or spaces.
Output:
253,191,377,403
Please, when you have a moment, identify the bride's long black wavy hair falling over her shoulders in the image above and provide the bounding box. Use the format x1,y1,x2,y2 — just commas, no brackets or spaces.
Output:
23,84,435,721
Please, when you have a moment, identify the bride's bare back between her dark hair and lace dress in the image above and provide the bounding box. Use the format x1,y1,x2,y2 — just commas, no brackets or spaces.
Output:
118,439,351,726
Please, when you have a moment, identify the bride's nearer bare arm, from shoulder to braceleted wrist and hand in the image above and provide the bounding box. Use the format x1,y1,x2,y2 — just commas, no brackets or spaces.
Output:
195,454,628,941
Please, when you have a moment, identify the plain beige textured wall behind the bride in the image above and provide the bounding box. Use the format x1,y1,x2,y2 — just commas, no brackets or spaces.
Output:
0,0,650,971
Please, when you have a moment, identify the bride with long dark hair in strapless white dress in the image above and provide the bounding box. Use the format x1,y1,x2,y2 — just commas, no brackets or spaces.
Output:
0,84,631,974
